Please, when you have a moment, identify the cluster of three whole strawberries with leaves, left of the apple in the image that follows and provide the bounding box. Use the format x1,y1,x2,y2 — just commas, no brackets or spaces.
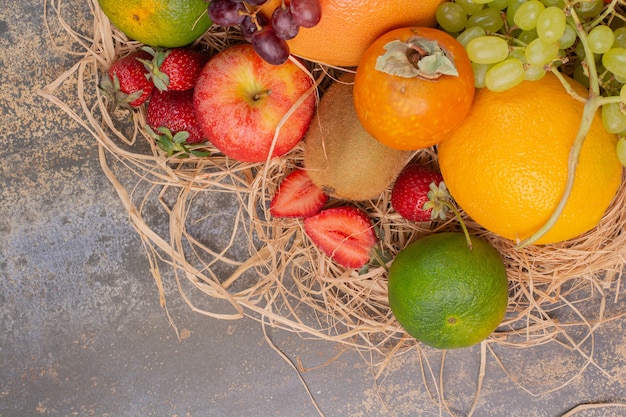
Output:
100,47,209,156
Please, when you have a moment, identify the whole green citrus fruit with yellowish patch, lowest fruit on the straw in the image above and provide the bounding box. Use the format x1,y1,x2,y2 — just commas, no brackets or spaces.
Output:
388,232,508,349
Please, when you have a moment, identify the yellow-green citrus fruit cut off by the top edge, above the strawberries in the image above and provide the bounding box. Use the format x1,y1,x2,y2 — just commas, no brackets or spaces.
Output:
98,0,211,48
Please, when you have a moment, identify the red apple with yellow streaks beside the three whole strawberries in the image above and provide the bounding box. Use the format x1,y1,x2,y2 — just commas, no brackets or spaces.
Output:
194,44,315,162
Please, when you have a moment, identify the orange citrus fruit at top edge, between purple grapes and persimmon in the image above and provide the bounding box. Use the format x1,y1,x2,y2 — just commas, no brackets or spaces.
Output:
262,0,445,67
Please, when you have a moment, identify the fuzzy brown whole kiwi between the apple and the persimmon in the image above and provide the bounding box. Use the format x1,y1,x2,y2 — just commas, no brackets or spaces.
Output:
304,73,412,201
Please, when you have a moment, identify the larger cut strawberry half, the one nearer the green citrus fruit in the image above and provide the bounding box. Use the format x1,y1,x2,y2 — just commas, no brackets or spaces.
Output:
304,206,378,268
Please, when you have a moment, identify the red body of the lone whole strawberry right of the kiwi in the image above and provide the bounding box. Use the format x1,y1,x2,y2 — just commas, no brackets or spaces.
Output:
391,163,443,222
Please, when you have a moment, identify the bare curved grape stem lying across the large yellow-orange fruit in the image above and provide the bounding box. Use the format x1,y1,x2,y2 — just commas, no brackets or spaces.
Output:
515,1,610,249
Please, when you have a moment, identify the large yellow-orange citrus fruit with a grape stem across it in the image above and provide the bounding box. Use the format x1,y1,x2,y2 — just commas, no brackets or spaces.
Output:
438,74,622,244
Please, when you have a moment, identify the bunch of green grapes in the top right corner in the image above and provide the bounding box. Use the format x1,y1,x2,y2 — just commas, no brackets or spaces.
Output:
436,0,626,162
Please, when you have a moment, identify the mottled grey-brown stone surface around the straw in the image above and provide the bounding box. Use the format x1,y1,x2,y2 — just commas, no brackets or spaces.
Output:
0,0,626,417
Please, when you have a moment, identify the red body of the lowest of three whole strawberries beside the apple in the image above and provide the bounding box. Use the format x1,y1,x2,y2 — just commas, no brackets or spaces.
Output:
146,90,205,153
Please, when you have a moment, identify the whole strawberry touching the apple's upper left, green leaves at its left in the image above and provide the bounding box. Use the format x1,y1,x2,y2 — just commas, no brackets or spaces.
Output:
142,46,208,91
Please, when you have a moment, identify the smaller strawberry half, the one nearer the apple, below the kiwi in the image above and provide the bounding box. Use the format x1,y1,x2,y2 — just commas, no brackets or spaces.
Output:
270,169,328,217
